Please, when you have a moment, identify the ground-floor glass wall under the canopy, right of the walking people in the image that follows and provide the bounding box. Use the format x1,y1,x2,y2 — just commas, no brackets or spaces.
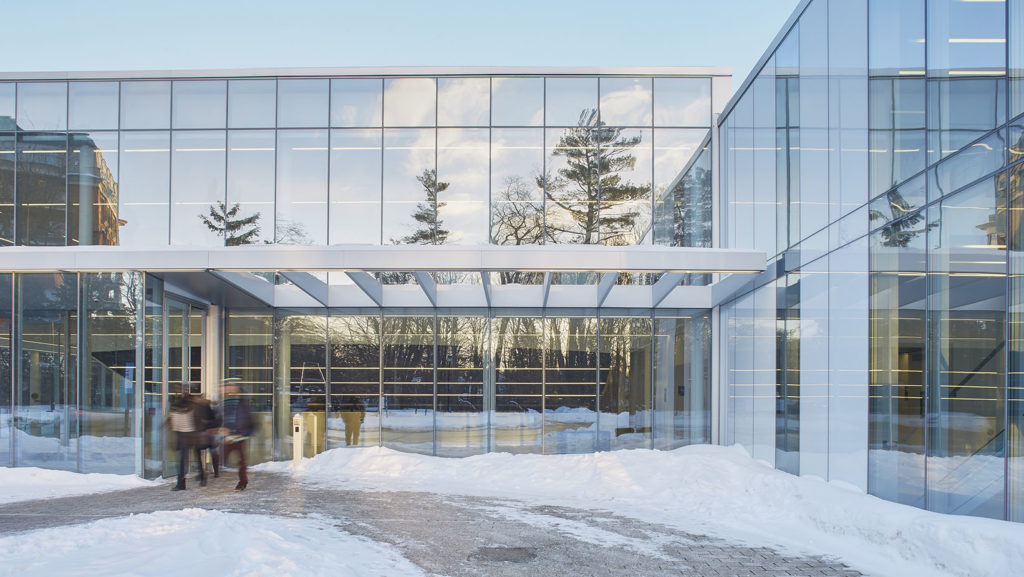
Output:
225,308,711,462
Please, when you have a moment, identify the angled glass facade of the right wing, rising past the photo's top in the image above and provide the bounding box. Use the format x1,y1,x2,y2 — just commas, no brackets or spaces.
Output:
717,0,1024,522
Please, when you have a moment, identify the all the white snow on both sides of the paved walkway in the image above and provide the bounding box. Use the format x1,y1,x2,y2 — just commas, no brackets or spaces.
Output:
0,446,1024,577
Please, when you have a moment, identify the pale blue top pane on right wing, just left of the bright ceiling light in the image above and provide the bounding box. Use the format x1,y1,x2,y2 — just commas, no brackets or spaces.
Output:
867,0,925,76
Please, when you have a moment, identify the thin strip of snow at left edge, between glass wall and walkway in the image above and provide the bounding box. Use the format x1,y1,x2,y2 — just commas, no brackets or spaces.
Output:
0,467,156,504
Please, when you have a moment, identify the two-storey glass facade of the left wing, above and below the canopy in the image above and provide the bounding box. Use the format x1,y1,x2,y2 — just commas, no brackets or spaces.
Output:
0,69,731,477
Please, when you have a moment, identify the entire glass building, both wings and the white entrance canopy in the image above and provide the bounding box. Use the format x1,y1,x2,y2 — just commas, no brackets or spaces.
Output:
0,0,1024,522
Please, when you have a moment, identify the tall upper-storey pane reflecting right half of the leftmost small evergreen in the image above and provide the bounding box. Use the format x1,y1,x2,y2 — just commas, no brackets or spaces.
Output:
224,130,276,245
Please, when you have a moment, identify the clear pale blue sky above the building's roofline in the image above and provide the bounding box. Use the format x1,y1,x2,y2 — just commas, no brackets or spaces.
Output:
0,0,799,91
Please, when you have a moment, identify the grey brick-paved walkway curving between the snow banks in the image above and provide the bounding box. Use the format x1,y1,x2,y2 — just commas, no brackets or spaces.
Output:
0,471,861,577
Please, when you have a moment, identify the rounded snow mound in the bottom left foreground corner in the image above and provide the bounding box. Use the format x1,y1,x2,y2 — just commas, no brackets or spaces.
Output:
0,508,424,577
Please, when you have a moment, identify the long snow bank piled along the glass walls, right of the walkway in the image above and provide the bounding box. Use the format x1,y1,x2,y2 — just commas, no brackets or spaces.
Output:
260,446,1024,577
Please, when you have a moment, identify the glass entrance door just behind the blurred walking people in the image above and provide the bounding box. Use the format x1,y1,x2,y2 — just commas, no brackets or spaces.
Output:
164,296,207,477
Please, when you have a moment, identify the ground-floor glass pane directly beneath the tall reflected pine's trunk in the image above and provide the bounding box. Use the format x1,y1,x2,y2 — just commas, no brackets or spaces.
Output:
544,317,598,454
